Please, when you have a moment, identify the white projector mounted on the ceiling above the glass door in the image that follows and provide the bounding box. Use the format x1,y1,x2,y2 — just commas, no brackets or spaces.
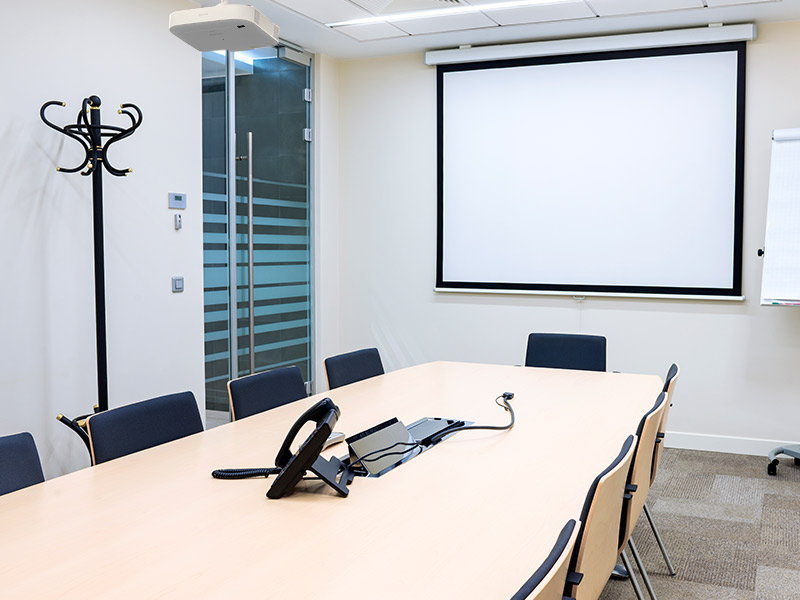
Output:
169,0,279,52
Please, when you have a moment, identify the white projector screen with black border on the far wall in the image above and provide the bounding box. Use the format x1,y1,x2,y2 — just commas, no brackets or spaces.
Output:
436,43,745,297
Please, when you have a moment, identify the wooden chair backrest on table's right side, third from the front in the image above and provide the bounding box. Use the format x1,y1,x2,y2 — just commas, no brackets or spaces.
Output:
619,392,667,552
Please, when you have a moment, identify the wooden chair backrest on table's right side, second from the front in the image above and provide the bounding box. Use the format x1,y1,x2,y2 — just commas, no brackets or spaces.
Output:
568,435,636,600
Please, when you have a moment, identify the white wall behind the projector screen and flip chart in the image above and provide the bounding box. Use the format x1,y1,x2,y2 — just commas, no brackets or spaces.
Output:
321,22,800,453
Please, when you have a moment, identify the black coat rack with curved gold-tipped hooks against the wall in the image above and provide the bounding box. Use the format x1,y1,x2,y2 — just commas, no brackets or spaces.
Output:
39,96,142,446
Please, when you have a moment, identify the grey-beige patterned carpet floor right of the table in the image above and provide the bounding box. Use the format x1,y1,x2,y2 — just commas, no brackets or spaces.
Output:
600,449,800,600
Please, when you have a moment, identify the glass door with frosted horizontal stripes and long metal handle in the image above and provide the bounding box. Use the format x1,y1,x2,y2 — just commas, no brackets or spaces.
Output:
203,48,312,425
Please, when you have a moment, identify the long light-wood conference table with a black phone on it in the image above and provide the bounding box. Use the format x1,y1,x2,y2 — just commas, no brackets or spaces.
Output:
0,362,662,600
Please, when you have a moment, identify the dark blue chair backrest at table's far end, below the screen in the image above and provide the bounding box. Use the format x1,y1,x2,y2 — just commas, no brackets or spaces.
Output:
525,333,606,371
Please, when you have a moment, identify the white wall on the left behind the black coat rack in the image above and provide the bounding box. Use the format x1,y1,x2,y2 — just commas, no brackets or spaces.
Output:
0,0,203,477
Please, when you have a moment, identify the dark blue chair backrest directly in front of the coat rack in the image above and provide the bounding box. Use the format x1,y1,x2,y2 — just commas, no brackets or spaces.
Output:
86,392,203,465
